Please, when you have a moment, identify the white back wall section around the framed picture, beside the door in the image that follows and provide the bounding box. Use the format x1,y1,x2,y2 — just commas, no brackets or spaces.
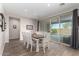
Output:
20,18,37,40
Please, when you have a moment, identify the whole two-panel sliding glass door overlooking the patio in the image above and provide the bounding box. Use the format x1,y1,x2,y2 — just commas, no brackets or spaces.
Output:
50,12,72,44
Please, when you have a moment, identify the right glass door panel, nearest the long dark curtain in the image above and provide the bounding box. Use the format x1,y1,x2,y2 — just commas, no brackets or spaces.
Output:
60,14,72,44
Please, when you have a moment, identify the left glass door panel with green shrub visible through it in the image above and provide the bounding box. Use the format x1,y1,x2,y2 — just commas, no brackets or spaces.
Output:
50,17,60,42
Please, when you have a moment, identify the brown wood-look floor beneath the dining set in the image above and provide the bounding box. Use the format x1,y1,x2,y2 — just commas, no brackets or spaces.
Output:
3,40,79,56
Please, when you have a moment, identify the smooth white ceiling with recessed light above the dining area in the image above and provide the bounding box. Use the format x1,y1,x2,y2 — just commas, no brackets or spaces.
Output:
3,3,79,19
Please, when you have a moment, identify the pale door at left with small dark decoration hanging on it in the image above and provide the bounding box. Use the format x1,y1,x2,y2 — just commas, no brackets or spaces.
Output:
9,17,20,40
